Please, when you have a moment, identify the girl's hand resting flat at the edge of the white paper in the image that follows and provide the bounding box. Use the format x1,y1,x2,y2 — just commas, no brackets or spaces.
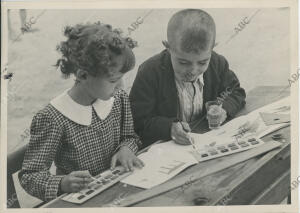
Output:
111,146,144,172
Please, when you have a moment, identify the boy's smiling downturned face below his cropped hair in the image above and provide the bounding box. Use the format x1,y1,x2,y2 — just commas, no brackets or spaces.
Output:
168,45,212,82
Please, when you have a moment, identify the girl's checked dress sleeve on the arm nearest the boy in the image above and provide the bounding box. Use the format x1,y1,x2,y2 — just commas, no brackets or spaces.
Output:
119,90,142,153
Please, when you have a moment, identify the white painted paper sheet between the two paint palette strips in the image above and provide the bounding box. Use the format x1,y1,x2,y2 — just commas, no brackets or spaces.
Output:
121,141,198,189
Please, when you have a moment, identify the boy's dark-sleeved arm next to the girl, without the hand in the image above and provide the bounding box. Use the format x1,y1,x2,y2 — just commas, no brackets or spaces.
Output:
130,65,176,146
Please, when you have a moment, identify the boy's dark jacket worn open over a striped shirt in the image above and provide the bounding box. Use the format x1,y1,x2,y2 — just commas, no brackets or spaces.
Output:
130,50,246,146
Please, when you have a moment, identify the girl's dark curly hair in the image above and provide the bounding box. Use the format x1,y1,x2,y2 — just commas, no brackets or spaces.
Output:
55,22,137,77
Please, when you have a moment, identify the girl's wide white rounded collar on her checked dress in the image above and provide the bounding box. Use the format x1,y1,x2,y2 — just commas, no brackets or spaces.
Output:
50,90,114,126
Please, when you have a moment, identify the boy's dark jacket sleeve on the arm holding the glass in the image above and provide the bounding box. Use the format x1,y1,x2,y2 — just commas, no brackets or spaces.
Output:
219,57,246,118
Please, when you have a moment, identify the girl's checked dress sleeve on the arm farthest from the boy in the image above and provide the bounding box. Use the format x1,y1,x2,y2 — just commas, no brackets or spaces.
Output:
19,112,64,201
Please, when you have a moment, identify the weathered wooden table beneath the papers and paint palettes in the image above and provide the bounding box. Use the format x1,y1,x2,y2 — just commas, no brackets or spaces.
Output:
44,86,290,208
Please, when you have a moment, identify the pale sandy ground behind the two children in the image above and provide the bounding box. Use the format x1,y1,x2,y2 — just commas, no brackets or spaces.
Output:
7,8,290,206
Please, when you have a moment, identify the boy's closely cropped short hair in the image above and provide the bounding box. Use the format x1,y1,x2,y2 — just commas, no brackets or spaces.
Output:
167,9,216,52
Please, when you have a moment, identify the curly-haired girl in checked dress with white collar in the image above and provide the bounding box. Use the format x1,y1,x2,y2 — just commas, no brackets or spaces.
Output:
19,22,143,201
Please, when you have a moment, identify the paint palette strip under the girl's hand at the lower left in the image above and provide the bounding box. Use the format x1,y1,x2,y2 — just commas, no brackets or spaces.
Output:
62,167,132,204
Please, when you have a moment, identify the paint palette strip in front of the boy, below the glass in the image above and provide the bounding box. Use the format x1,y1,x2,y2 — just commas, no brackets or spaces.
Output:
191,137,264,162
